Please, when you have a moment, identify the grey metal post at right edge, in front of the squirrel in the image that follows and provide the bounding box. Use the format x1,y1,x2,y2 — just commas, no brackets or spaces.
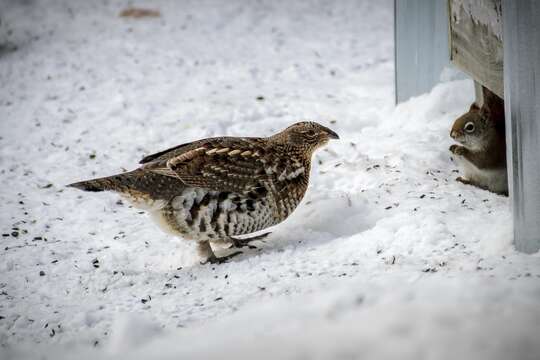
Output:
502,0,540,253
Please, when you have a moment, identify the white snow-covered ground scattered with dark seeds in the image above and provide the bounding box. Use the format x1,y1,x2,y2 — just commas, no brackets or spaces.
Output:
0,0,540,359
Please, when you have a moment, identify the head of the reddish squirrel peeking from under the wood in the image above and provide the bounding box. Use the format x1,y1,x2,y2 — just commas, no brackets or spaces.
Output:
450,103,498,151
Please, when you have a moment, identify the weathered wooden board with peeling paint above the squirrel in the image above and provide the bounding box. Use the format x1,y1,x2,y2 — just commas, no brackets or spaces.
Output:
448,0,504,98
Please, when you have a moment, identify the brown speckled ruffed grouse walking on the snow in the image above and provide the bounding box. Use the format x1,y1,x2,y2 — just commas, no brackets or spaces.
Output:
68,122,339,263
